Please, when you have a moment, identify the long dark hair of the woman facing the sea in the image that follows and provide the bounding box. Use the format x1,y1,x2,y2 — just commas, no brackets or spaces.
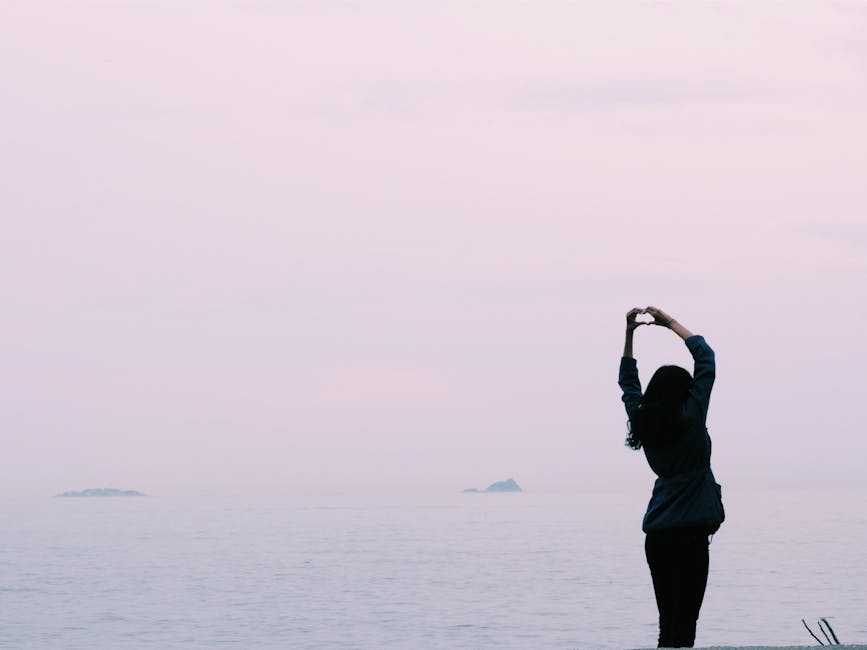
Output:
626,366,692,449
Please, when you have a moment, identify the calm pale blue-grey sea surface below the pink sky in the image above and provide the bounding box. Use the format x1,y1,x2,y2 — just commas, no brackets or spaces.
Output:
0,490,867,650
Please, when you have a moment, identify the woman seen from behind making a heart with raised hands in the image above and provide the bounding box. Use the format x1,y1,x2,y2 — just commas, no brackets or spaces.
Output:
619,307,725,648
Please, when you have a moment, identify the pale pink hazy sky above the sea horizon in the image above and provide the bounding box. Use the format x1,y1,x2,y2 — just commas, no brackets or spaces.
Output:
0,0,867,496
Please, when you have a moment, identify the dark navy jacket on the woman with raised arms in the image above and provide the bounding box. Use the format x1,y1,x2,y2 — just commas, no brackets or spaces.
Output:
618,336,725,533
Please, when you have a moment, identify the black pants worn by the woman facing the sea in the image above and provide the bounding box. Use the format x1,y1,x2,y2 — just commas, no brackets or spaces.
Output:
644,528,708,648
